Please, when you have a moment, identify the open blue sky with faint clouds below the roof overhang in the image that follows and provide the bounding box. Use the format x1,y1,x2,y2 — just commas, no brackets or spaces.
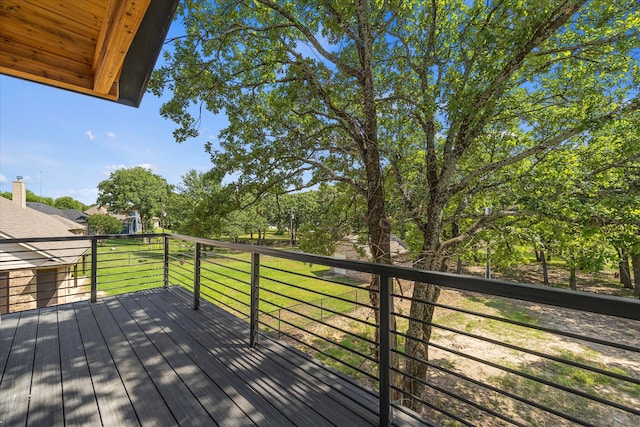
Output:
0,32,226,204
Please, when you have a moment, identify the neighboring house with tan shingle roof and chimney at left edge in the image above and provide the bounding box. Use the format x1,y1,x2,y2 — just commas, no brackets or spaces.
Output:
0,180,90,314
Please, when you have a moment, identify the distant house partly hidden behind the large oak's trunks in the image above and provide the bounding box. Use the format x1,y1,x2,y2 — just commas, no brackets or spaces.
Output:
329,234,409,281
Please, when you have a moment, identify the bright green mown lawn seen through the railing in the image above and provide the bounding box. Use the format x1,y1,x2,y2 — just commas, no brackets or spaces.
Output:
98,238,367,326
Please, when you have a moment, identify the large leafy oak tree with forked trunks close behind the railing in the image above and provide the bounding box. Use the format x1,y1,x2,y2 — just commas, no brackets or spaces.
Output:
151,0,640,409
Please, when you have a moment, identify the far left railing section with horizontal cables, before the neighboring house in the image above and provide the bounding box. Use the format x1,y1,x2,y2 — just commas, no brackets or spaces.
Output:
0,235,164,314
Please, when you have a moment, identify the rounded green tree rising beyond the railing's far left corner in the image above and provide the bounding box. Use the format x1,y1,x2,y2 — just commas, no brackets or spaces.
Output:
97,166,171,233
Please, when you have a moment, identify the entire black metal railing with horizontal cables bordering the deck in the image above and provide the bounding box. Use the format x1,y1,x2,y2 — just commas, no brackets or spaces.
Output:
0,234,640,426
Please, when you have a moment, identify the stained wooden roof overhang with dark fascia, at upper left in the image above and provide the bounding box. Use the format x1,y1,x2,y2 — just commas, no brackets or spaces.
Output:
0,0,179,107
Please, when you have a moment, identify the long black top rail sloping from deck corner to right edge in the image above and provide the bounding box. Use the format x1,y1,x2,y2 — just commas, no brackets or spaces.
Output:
168,234,640,320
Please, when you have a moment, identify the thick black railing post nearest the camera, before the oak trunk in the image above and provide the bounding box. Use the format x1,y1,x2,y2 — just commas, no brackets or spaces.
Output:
378,275,392,427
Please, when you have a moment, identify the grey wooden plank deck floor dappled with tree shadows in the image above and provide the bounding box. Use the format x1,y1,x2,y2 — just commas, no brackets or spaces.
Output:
0,287,428,427
